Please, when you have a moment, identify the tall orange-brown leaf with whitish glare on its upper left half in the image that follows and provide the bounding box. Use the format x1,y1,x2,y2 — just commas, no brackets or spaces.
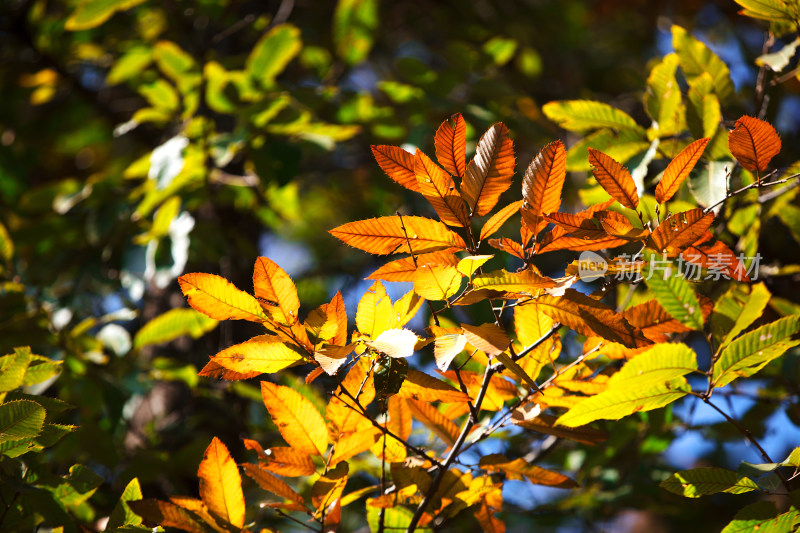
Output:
461,122,516,216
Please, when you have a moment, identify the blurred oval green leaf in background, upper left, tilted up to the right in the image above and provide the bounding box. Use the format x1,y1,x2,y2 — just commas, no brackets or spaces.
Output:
247,24,303,87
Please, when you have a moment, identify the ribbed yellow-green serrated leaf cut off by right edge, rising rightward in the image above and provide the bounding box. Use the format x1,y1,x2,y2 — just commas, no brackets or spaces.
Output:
713,315,800,387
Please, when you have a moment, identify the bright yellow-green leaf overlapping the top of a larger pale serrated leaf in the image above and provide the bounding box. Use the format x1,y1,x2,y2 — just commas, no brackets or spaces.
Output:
608,343,697,390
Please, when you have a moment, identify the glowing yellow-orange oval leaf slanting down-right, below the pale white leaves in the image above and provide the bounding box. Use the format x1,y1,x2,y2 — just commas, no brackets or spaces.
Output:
261,381,328,455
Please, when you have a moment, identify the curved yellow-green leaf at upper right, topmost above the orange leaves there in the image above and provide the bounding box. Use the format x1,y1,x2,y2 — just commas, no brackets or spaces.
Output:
672,25,736,103
